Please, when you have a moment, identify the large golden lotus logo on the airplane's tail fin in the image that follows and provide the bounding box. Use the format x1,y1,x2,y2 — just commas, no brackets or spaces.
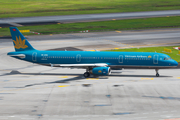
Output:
13,36,28,49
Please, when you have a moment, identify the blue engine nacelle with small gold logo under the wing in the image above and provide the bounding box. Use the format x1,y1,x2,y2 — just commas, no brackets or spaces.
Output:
92,67,111,75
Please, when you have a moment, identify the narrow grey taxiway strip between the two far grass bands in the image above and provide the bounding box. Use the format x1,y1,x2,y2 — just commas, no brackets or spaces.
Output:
0,10,180,27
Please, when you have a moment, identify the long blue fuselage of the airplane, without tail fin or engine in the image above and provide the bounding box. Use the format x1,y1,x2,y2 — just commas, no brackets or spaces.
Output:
8,50,178,69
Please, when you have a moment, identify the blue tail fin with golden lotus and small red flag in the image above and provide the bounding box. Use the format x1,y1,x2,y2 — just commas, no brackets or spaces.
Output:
9,27,35,51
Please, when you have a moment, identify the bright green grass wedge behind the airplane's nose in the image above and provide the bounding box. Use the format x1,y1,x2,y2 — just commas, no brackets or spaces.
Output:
107,46,180,62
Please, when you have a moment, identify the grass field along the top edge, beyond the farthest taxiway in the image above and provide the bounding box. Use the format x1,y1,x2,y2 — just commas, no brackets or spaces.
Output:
0,0,180,18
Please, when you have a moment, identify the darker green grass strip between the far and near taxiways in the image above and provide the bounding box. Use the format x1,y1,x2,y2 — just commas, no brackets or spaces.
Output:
0,16,180,36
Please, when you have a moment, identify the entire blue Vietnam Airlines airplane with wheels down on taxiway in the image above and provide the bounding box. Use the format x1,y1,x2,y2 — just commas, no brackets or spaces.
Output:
7,27,178,78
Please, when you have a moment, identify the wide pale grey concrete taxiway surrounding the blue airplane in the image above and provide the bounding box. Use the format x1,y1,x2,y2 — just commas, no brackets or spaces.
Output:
0,29,180,120
